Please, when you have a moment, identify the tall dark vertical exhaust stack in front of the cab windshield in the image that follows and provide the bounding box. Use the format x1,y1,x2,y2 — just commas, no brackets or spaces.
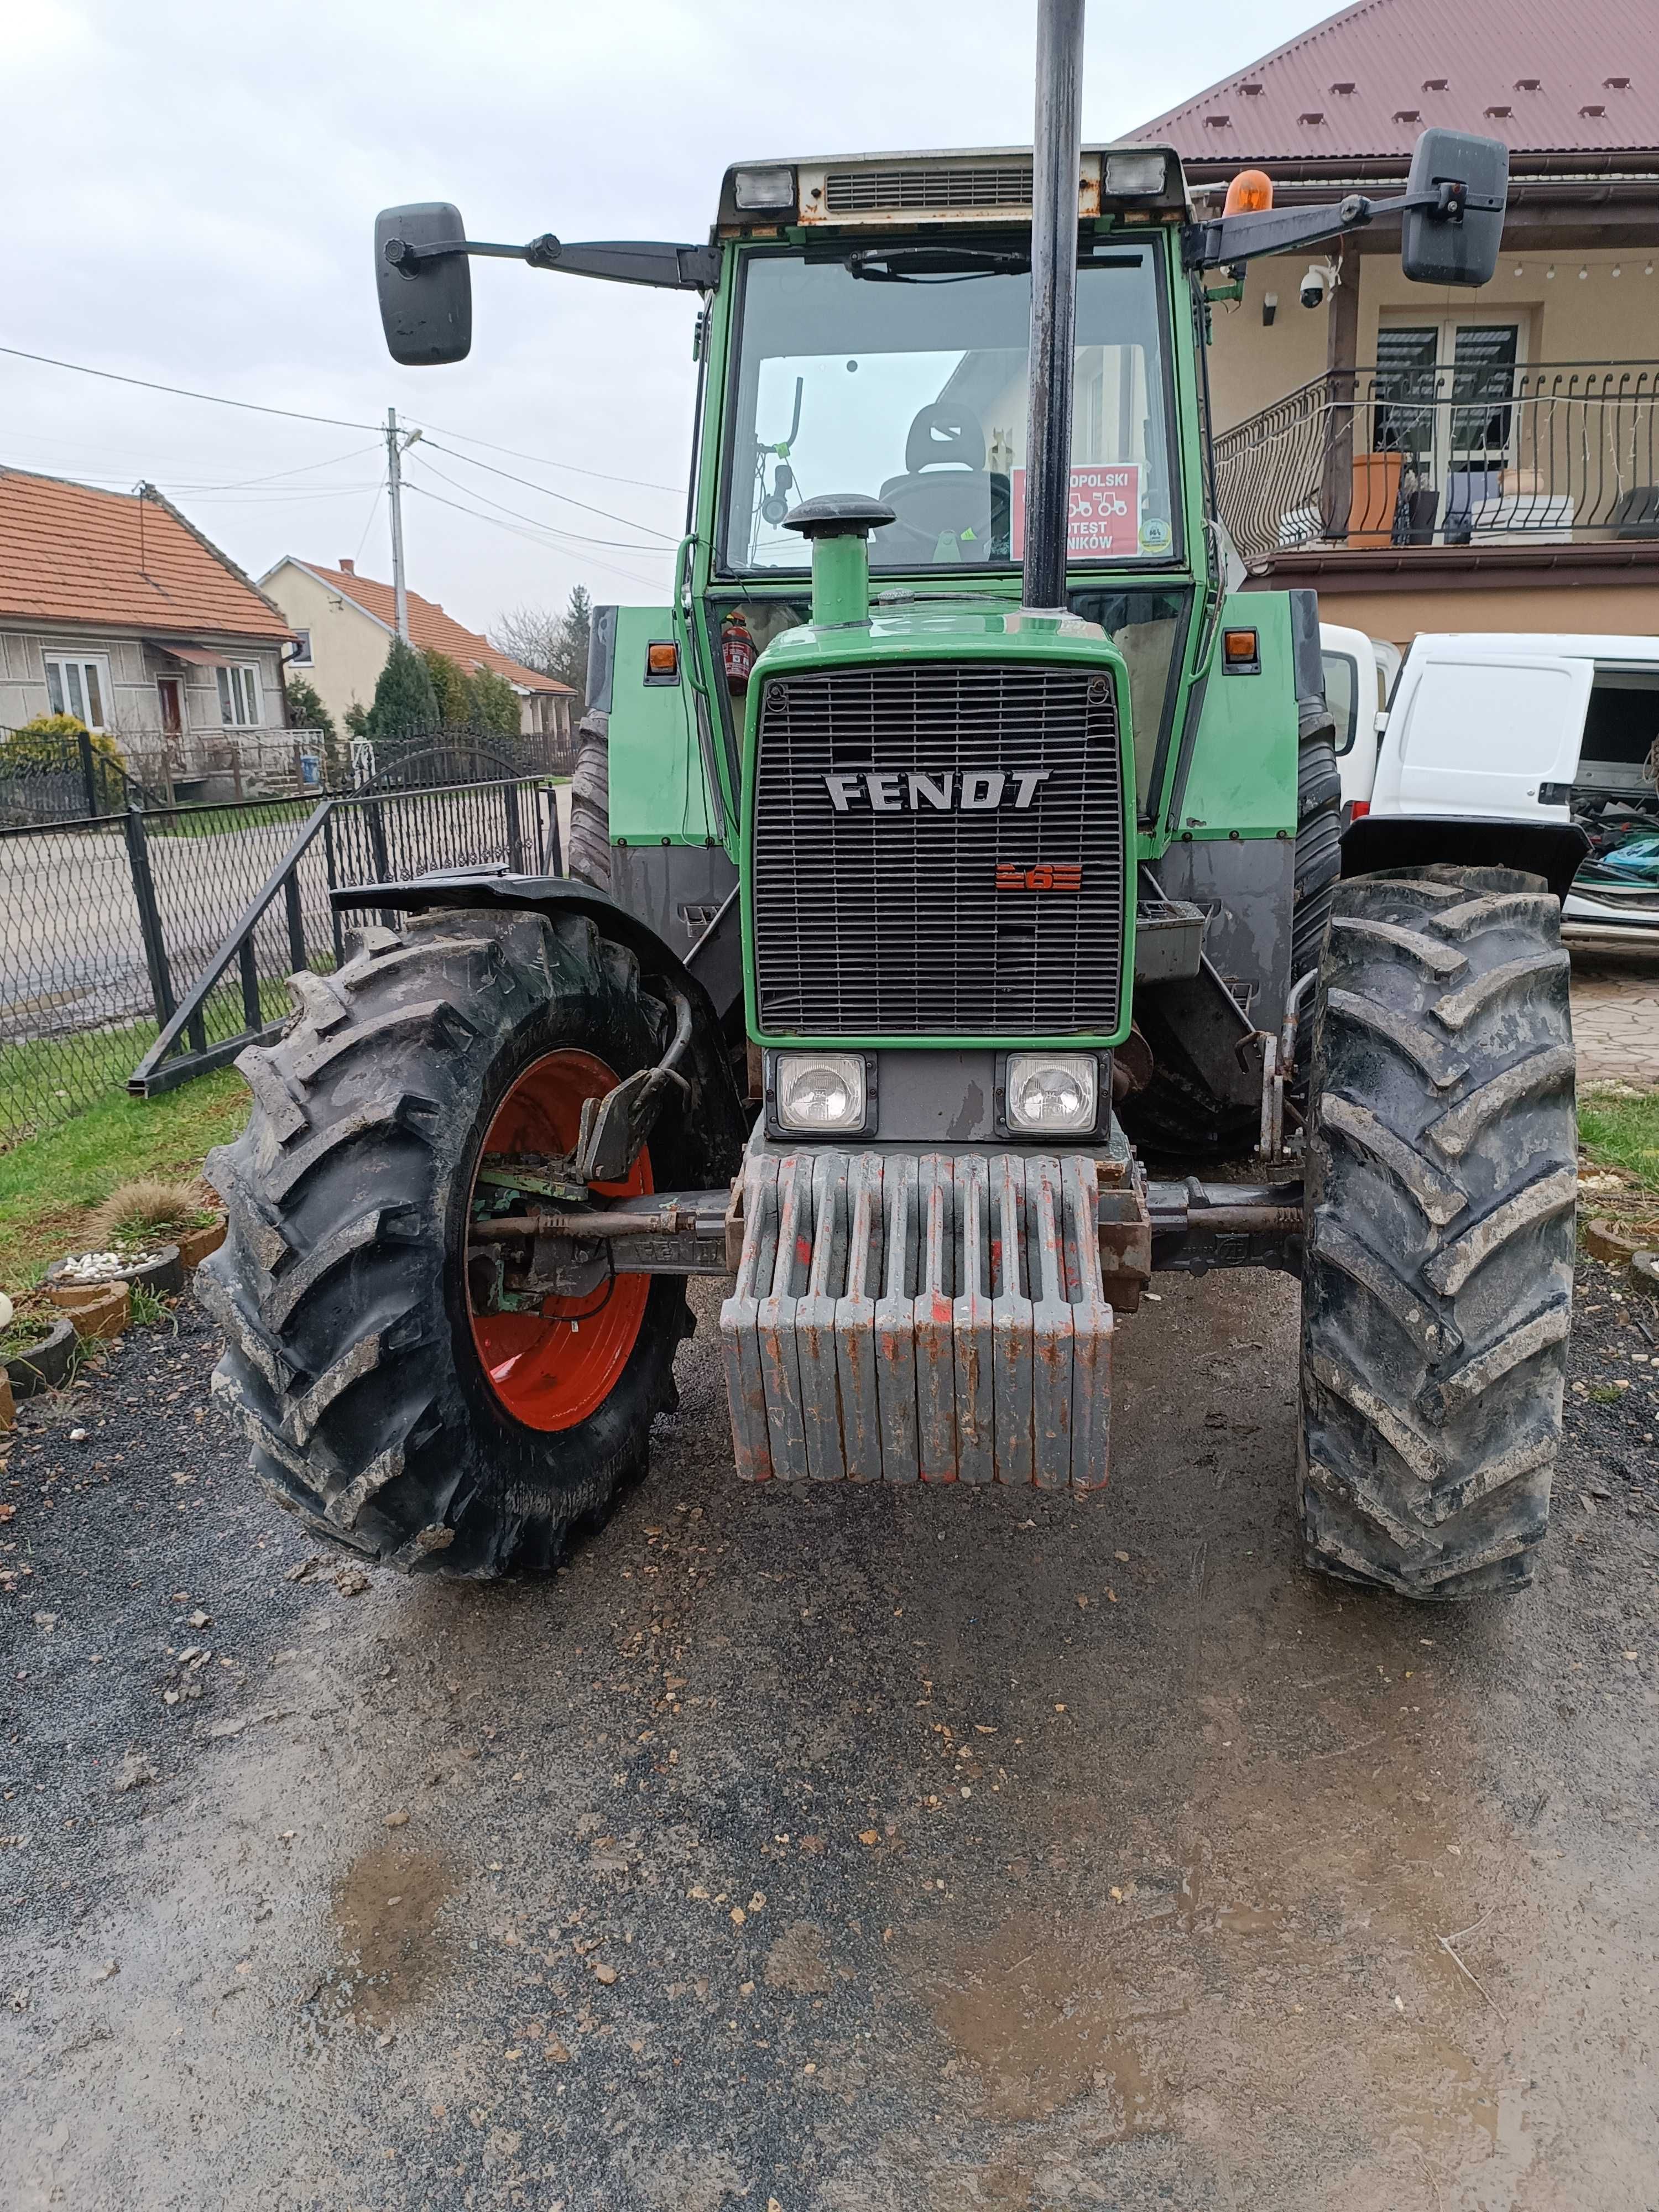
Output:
1022,0,1084,613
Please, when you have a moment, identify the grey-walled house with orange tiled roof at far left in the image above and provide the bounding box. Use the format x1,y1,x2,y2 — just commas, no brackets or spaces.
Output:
0,467,292,785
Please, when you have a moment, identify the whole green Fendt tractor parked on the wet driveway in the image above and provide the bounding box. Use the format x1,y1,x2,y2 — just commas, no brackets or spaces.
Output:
204,0,1582,1599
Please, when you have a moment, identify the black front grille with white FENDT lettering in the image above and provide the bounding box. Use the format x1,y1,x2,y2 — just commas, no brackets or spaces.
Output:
752,661,1126,1037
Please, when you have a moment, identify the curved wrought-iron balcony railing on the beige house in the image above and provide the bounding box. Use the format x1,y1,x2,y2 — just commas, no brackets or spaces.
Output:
1214,361,1659,562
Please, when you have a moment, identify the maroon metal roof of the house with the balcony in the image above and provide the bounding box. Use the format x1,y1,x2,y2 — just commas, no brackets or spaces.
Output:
1133,0,1659,161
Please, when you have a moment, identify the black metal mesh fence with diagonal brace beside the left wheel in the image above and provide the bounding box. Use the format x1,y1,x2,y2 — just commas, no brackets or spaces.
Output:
0,776,560,1146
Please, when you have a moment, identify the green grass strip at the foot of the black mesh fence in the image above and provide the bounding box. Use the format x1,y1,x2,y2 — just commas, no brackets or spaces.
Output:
0,1068,248,1296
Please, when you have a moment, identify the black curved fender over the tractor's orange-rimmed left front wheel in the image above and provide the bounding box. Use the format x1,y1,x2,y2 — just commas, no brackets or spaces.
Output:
330,872,750,1188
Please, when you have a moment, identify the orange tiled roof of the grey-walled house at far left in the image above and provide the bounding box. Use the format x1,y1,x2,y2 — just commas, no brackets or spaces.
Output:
0,469,292,639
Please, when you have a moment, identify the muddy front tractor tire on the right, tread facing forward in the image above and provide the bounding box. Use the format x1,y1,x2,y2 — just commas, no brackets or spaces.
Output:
1301,867,1577,1599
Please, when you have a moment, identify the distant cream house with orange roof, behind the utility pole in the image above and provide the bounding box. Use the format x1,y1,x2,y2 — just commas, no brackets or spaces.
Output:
259,555,575,745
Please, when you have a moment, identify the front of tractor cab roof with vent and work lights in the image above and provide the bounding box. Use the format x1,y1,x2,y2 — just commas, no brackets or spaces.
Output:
714,144,1188,239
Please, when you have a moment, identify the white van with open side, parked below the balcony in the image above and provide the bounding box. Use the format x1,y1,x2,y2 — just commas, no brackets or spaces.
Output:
1354,630,1659,929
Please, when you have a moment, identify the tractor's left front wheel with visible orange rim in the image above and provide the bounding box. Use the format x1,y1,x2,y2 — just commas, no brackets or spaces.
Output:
199,911,703,1577
